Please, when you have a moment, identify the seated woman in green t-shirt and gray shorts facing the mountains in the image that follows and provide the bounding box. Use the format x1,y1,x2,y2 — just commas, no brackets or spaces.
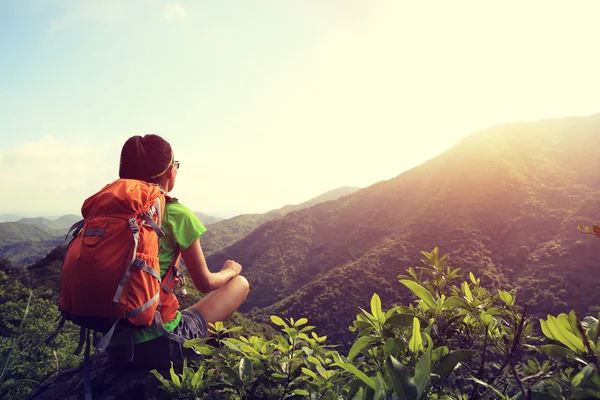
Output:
107,134,249,367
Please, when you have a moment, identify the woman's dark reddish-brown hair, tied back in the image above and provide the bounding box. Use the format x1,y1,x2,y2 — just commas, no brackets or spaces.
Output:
119,134,173,182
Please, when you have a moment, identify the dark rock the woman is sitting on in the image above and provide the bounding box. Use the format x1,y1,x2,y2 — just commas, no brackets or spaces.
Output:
28,353,169,400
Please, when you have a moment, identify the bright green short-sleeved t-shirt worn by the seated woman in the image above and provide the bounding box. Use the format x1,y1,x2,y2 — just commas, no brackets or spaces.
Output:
111,201,206,345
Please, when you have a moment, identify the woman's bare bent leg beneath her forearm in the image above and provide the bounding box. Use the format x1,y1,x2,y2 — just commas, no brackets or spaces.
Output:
184,275,250,324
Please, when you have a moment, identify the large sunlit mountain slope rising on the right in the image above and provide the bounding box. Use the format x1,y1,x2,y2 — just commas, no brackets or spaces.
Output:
208,114,600,343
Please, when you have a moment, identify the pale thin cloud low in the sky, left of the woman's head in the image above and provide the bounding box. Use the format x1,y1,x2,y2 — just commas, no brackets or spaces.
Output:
0,135,120,214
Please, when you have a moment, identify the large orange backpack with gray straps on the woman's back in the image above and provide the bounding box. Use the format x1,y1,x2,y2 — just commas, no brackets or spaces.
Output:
53,179,186,351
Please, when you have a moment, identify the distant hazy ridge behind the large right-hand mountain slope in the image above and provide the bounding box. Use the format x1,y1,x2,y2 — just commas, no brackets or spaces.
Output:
200,186,360,256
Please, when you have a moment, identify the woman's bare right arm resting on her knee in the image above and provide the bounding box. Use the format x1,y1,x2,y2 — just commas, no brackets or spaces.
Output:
181,239,242,293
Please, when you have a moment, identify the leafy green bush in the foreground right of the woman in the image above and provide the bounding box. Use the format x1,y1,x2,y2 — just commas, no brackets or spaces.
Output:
153,248,600,400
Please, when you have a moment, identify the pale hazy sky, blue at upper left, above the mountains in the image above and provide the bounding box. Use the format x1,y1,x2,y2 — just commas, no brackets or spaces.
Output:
0,0,600,217
